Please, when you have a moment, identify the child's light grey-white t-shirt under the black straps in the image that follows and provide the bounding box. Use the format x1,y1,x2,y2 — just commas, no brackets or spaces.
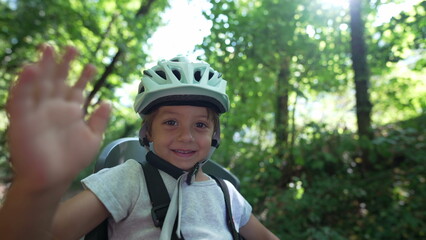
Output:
82,160,252,240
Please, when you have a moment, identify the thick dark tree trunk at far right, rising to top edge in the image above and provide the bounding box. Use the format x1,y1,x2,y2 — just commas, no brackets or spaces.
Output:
350,0,373,139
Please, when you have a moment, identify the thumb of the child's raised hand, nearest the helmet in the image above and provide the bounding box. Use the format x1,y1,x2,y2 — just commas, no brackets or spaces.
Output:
87,102,111,136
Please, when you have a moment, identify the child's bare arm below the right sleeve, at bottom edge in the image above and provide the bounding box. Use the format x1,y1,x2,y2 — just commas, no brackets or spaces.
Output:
240,215,279,240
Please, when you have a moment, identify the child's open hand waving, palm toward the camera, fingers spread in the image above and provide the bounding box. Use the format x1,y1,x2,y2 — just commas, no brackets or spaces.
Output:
7,46,110,191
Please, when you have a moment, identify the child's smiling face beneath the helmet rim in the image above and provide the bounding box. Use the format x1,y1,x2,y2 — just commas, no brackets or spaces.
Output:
149,106,214,170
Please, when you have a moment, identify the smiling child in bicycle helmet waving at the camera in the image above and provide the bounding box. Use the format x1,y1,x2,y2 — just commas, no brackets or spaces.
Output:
0,46,277,239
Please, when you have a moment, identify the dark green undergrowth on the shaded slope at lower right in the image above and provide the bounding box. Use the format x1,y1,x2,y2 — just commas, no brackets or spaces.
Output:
255,124,426,239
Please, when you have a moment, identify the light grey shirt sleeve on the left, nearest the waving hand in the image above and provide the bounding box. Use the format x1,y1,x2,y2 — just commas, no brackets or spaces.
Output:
81,160,142,222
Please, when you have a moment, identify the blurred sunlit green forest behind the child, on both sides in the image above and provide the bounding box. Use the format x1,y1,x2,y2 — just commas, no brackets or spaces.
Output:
0,0,426,240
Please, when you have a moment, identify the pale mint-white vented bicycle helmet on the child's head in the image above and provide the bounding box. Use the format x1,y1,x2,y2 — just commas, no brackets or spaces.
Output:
134,56,229,152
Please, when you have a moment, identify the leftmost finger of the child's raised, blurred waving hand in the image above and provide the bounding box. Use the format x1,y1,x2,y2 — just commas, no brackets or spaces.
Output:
6,65,39,118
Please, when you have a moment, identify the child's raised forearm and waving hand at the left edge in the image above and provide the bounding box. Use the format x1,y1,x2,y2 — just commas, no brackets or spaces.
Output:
0,46,111,239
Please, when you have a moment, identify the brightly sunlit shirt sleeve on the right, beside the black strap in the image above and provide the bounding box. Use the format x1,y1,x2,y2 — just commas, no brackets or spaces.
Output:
225,180,252,230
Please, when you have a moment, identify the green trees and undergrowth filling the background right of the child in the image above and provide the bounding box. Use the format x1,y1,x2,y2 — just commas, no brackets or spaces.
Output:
200,0,426,239
